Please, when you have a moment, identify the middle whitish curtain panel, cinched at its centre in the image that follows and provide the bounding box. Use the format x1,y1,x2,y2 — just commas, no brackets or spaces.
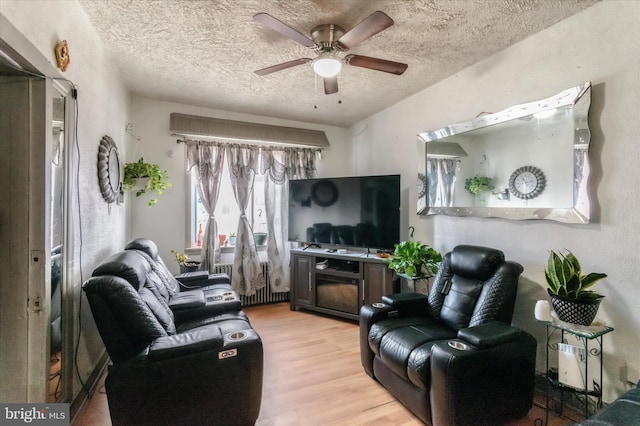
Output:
227,145,264,296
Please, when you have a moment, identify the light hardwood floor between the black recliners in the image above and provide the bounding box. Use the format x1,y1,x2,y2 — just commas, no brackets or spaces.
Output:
72,303,577,426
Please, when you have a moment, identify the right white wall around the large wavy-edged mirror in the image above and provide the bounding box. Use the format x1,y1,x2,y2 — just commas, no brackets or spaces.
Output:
353,1,640,401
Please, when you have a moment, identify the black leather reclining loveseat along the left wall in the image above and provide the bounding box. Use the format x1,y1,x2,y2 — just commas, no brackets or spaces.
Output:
83,241,263,426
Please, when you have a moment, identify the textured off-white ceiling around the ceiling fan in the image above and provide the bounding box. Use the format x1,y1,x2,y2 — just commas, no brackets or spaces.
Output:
77,0,597,126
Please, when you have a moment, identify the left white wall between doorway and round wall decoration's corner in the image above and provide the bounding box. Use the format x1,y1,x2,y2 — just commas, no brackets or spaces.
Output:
0,0,129,402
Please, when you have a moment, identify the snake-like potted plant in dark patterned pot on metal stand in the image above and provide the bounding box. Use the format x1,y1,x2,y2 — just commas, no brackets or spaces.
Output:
544,250,607,325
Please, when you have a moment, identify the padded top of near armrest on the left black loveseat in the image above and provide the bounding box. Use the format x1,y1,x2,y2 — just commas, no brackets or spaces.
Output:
148,325,224,361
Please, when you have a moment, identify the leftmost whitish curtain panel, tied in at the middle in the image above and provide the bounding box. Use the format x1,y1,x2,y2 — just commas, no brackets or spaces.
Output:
185,140,225,270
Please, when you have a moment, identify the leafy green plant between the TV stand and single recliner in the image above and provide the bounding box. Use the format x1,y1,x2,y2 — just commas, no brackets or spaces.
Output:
384,240,442,279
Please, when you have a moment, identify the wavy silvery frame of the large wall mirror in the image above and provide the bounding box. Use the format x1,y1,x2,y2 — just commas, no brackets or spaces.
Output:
417,82,591,224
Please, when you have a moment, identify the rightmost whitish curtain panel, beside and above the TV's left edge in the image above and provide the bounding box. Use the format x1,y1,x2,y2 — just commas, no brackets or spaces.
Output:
262,148,319,293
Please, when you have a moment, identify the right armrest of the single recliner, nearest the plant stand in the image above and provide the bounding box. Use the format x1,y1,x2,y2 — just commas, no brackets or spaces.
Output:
429,323,537,425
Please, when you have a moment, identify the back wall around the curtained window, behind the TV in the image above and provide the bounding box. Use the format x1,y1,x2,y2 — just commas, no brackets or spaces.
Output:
125,96,352,272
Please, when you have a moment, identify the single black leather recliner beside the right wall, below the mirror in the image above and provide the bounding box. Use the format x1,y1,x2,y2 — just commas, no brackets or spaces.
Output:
360,245,536,425
